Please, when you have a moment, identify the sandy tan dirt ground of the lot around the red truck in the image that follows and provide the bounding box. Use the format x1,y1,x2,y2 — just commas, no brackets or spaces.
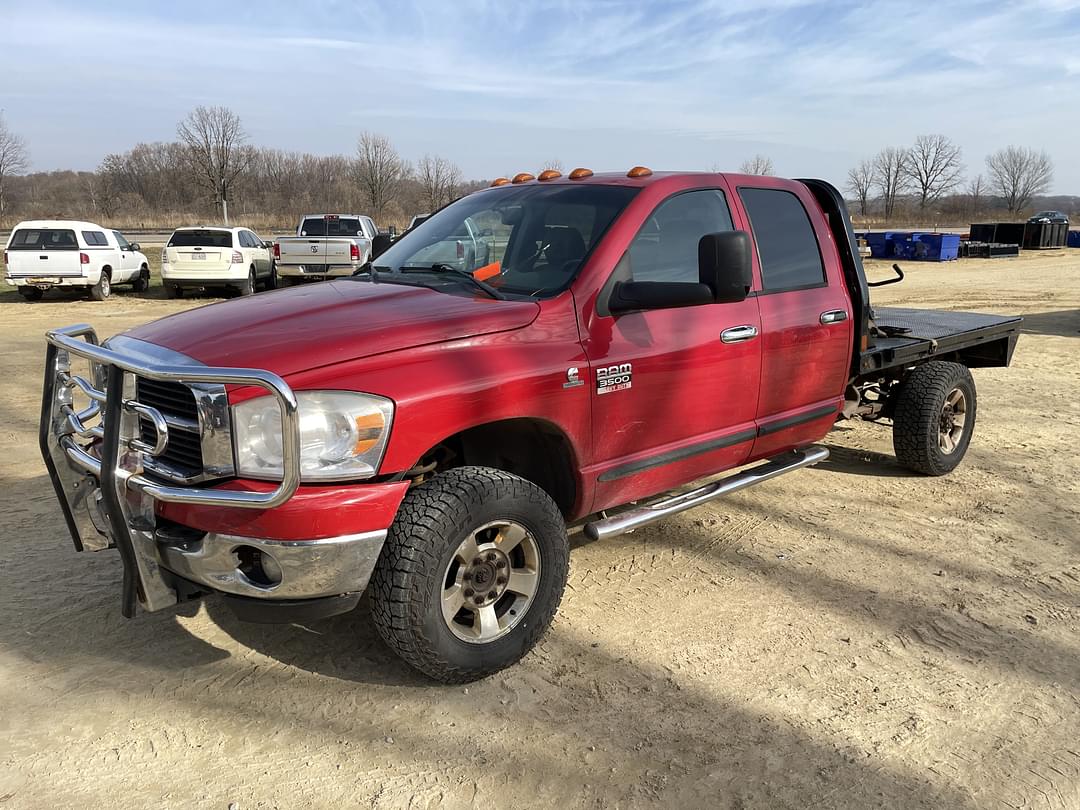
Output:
0,251,1080,810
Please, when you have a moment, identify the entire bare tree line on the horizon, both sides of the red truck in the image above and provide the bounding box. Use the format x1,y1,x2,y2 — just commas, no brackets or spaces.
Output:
0,107,1067,228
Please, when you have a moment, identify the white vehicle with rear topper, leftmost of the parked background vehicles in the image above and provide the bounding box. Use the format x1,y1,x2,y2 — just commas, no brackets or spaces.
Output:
3,219,150,301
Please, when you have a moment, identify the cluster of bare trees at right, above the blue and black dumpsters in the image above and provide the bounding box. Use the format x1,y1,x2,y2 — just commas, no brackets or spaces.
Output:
846,135,1054,222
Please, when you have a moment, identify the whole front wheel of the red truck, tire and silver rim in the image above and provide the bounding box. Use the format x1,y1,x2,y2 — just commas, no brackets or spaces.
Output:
368,467,569,684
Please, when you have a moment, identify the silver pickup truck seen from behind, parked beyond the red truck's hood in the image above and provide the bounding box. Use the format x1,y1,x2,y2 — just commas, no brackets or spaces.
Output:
274,214,379,286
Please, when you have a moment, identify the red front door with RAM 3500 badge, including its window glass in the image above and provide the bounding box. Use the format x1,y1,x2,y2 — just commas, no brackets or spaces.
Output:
585,189,761,511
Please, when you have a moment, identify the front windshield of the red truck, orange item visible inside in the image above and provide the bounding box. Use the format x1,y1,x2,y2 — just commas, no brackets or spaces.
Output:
375,185,637,298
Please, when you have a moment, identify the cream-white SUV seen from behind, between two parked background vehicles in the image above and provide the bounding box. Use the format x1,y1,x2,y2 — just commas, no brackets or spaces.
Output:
161,226,278,298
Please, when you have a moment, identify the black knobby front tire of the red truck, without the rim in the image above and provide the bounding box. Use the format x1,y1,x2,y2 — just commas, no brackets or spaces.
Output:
368,467,569,684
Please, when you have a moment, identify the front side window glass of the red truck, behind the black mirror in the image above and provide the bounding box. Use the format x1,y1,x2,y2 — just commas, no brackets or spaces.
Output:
630,189,732,282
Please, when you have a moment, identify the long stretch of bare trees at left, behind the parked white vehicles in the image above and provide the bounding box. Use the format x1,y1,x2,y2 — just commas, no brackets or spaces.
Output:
0,107,483,228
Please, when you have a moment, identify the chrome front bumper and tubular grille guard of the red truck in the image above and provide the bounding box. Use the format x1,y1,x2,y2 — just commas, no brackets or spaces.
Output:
39,326,401,617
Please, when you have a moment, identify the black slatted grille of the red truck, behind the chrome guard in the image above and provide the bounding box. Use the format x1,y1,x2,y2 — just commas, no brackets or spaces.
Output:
135,377,203,478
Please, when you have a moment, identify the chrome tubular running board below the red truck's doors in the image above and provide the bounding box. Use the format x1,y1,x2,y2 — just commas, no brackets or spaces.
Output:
583,447,828,540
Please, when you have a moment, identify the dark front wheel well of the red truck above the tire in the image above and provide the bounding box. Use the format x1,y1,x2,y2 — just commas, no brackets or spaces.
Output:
405,419,578,515
